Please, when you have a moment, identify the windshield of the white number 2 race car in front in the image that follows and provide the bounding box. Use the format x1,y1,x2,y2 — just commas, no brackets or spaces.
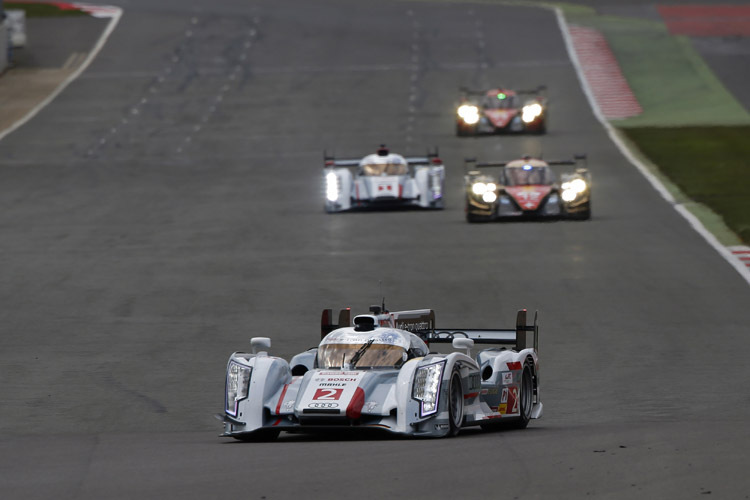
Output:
318,342,407,369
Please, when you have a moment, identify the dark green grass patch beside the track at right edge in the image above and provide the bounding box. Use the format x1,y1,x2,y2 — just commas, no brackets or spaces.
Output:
621,126,750,244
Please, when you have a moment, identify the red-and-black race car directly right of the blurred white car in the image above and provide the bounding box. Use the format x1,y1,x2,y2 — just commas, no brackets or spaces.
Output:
465,155,591,222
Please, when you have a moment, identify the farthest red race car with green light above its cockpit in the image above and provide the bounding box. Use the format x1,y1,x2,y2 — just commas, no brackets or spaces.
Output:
456,86,547,136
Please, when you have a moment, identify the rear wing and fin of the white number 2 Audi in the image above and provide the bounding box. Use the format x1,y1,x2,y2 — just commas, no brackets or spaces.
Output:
320,306,539,351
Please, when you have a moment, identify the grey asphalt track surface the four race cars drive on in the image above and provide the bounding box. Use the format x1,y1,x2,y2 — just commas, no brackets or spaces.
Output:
0,0,750,499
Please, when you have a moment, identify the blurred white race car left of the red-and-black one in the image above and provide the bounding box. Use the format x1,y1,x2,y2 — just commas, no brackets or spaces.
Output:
323,145,445,213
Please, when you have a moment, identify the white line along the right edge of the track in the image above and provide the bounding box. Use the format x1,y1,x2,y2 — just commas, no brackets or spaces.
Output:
554,7,750,284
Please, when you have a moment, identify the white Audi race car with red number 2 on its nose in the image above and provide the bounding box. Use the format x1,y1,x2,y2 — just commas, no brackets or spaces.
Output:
217,306,542,441
